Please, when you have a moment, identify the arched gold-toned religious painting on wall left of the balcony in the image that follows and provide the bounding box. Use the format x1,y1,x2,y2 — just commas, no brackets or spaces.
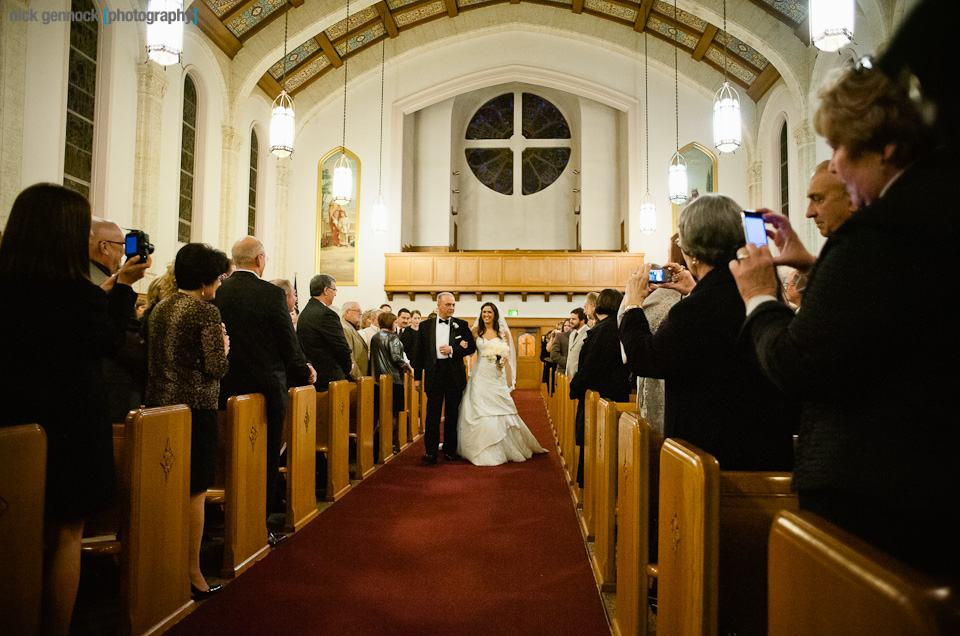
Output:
316,147,360,286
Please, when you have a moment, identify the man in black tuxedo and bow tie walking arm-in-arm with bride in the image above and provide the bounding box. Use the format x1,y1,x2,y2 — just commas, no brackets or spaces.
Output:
414,292,477,464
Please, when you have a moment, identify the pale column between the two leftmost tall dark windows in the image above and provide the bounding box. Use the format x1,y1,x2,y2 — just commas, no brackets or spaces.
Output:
133,62,169,243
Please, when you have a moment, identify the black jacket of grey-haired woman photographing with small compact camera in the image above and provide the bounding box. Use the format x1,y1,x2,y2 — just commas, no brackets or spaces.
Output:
624,265,798,470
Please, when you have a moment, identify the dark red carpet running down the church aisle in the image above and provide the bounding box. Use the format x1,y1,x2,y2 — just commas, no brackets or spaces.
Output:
168,391,610,636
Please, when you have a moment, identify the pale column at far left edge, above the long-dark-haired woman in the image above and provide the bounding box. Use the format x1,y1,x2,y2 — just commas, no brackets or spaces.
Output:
0,0,30,230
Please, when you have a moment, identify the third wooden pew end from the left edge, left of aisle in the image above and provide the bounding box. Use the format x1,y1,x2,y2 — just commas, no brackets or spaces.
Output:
220,393,270,578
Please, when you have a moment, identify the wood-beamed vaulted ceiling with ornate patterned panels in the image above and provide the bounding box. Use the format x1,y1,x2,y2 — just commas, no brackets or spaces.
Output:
191,0,808,101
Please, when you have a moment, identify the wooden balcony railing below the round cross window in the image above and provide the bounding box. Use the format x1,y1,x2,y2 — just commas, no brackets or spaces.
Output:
383,250,644,302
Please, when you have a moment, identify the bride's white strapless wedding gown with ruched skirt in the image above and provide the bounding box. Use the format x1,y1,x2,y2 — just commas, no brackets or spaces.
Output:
457,337,547,466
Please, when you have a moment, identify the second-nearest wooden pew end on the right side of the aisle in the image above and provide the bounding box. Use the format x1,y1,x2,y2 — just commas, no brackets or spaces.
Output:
657,439,720,636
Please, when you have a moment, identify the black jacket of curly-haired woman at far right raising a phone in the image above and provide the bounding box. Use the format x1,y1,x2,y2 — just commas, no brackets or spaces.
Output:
744,145,960,512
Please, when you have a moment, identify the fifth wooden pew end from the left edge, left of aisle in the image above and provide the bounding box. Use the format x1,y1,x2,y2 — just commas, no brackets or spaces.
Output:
316,380,350,501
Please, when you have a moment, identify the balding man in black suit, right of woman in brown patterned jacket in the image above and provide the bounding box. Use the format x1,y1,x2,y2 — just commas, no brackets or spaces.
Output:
213,236,317,545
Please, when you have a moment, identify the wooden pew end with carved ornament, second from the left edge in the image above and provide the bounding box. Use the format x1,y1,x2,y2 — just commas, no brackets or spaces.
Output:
120,408,195,634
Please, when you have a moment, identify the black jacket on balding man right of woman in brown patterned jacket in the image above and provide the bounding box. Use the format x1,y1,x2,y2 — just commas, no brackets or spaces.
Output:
213,270,310,414
